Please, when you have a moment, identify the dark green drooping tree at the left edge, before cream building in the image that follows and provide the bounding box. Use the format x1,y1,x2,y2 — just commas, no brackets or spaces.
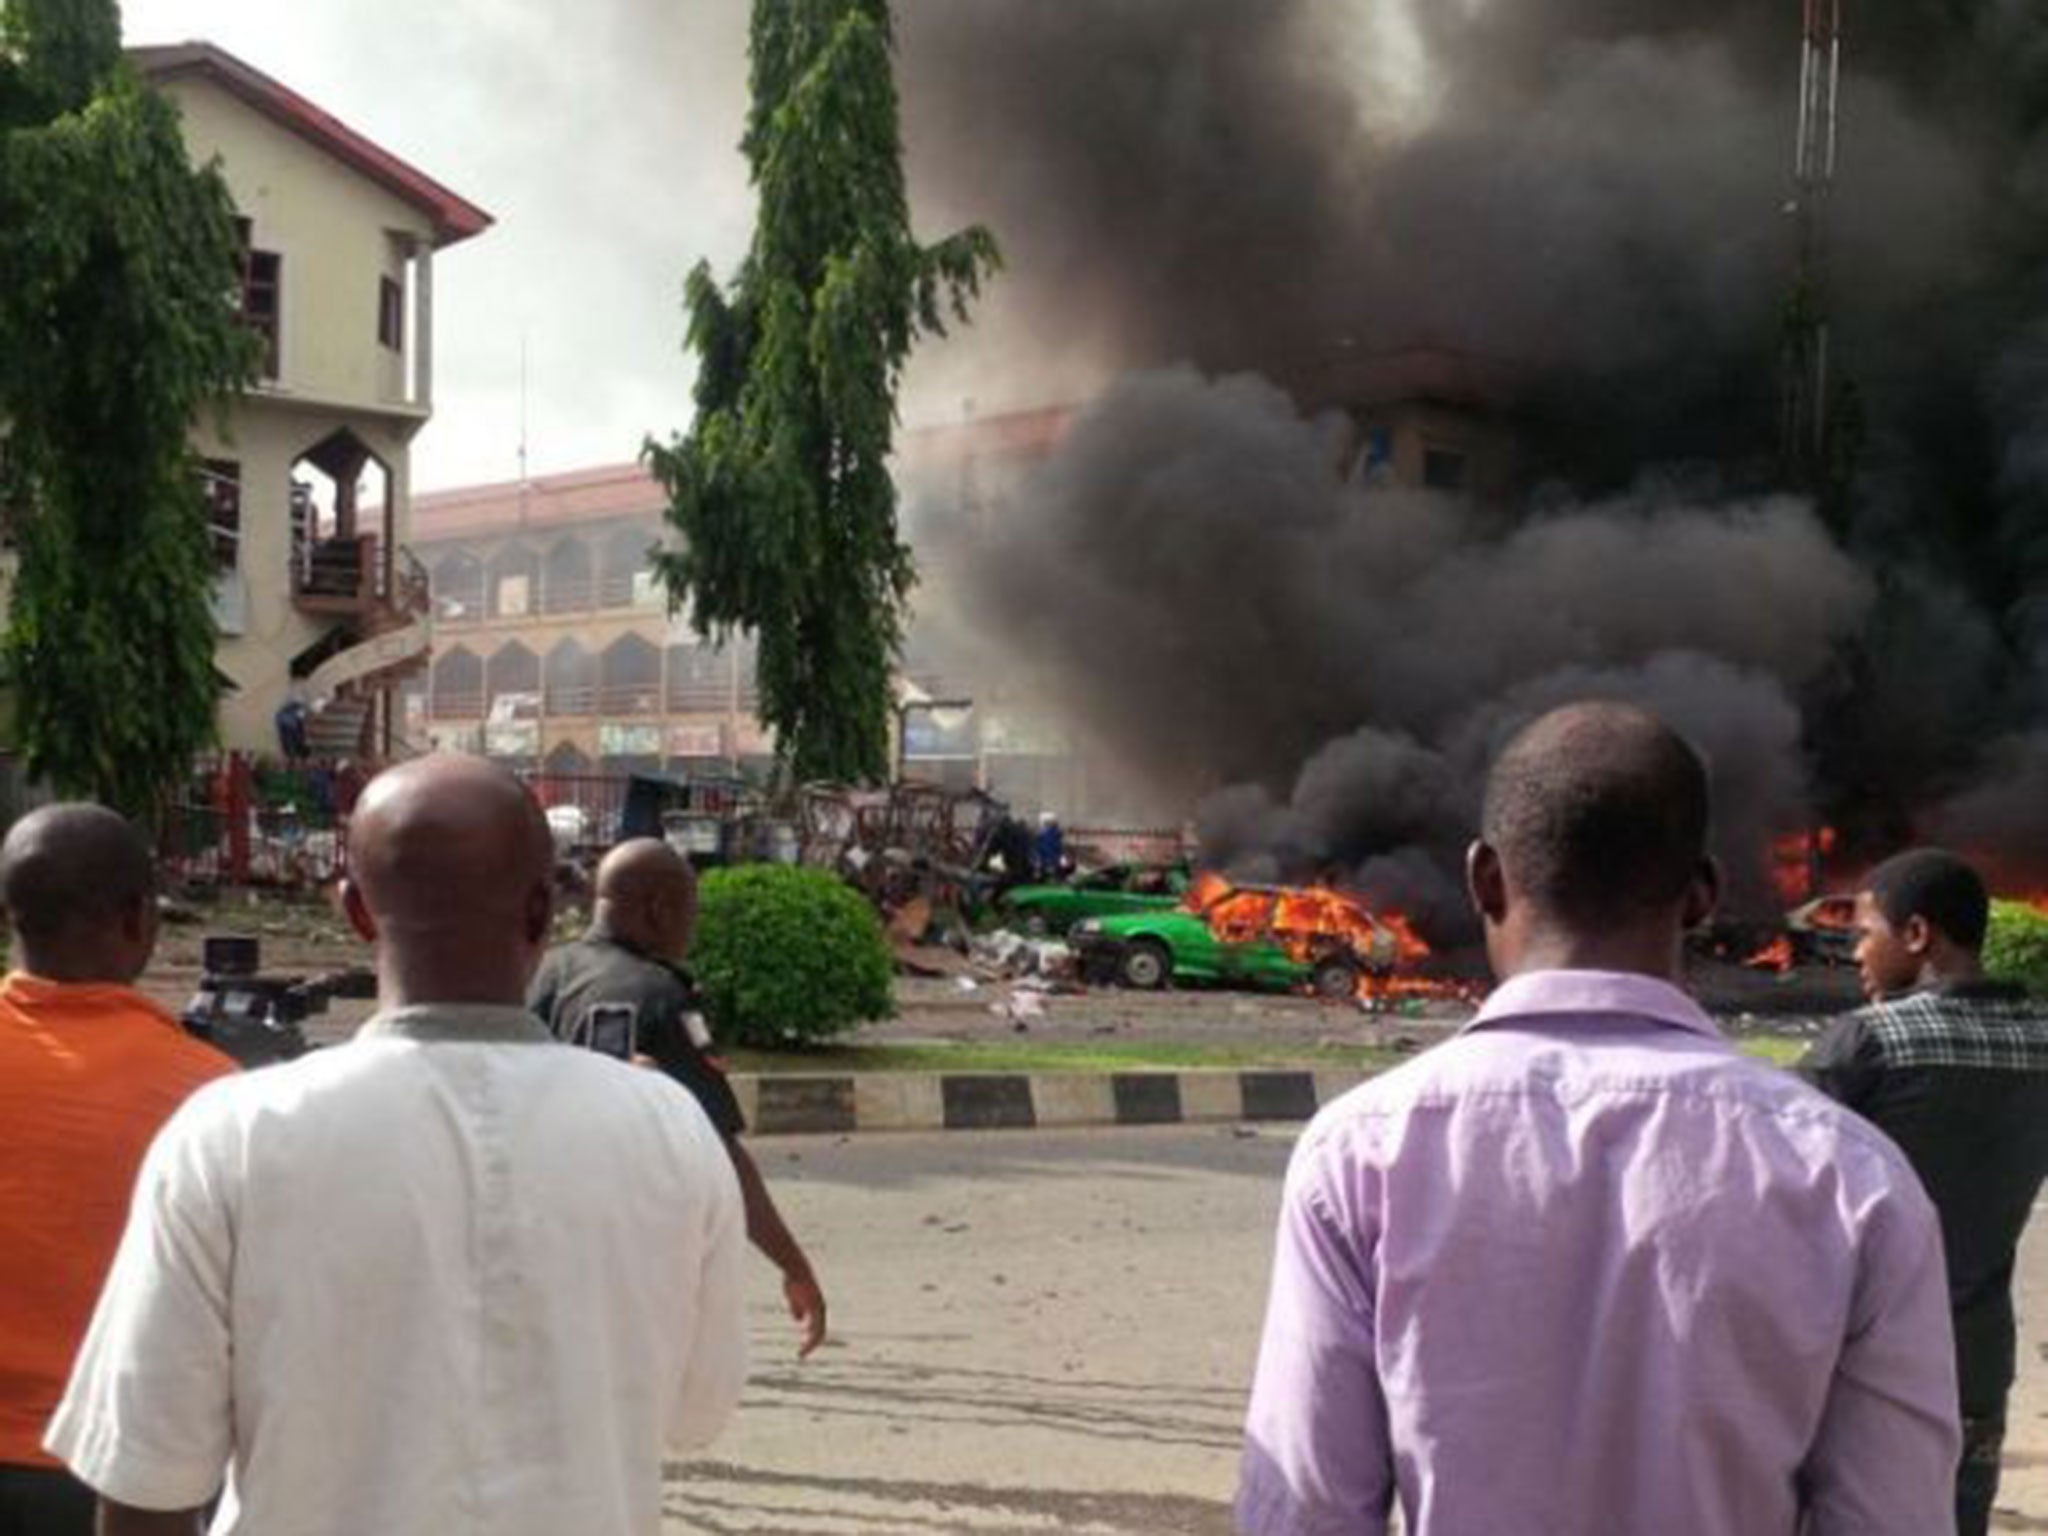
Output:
0,0,256,813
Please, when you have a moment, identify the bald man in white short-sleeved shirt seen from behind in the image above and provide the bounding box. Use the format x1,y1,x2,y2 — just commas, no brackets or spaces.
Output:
49,756,745,1536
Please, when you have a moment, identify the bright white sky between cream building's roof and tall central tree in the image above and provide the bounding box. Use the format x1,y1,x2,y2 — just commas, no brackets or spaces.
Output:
123,0,790,489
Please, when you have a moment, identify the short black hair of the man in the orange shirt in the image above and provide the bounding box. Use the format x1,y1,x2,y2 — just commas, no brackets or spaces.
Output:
0,803,156,944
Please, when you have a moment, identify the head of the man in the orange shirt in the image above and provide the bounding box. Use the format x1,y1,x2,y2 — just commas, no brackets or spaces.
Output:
0,805,156,985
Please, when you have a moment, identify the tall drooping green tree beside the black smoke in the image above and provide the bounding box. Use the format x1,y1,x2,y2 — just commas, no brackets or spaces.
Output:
645,0,999,780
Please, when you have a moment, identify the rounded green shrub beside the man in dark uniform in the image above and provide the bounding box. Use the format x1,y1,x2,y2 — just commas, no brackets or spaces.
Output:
690,864,895,1049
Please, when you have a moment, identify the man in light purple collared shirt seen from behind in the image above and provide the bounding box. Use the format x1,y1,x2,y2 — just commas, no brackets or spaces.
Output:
1237,705,1958,1536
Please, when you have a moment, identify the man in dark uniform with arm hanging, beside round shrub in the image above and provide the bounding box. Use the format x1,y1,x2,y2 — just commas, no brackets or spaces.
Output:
528,838,825,1358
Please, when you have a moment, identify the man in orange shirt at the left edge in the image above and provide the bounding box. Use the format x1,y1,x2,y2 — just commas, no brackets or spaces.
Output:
0,805,236,1536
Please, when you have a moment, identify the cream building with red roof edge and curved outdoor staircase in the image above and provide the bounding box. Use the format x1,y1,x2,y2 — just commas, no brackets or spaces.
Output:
129,43,492,756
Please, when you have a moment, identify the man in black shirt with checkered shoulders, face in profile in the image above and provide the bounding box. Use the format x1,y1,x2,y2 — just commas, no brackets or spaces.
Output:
1800,848,2048,1536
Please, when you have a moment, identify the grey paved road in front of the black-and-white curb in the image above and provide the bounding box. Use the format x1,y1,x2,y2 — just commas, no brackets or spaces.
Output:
670,1126,2048,1536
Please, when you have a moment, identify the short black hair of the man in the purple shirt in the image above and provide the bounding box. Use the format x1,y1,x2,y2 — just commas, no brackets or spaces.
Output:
1483,702,1710,924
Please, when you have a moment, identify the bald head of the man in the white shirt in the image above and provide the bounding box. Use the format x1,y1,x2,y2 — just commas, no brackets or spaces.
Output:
344,754,555,1001
